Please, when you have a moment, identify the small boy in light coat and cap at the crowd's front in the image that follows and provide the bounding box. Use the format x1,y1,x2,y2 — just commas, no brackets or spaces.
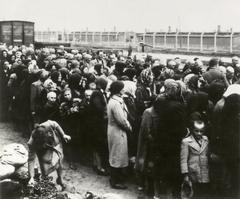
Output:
180,120,210,198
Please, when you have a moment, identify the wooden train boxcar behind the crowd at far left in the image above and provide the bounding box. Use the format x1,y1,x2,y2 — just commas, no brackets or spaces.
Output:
0,21,34,46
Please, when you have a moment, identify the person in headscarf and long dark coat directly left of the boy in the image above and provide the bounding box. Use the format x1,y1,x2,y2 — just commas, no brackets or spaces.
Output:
151,82,187,198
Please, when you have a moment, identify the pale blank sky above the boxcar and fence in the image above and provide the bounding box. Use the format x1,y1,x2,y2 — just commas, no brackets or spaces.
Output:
0,0,240,32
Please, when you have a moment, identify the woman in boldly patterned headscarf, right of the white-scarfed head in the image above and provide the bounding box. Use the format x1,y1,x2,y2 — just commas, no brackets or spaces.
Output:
136,69,153,115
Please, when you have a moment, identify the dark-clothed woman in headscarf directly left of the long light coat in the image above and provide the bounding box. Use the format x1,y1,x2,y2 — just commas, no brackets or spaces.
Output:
90,77,108,175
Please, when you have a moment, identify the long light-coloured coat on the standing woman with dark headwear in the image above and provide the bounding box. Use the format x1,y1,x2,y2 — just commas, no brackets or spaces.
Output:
107,95,131,168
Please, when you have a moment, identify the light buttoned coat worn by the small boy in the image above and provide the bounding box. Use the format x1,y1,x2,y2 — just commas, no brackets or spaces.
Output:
180,135,210,183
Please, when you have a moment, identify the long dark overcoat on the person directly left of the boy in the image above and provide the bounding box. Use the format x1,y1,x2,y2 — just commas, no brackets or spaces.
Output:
151,96,187,183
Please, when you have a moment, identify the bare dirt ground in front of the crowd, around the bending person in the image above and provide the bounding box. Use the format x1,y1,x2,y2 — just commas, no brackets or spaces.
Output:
0,122,138,199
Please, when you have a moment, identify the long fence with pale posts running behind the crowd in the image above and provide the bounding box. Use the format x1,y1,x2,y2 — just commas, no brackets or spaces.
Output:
35,31,240,53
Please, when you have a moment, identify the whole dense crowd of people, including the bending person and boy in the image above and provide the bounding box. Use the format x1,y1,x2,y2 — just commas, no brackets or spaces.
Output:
0,45,240,199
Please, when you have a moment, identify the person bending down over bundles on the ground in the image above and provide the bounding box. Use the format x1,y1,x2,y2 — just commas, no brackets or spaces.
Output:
28,120,71,190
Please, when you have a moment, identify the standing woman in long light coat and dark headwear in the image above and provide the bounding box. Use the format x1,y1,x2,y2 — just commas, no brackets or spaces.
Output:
107,81,132,189
